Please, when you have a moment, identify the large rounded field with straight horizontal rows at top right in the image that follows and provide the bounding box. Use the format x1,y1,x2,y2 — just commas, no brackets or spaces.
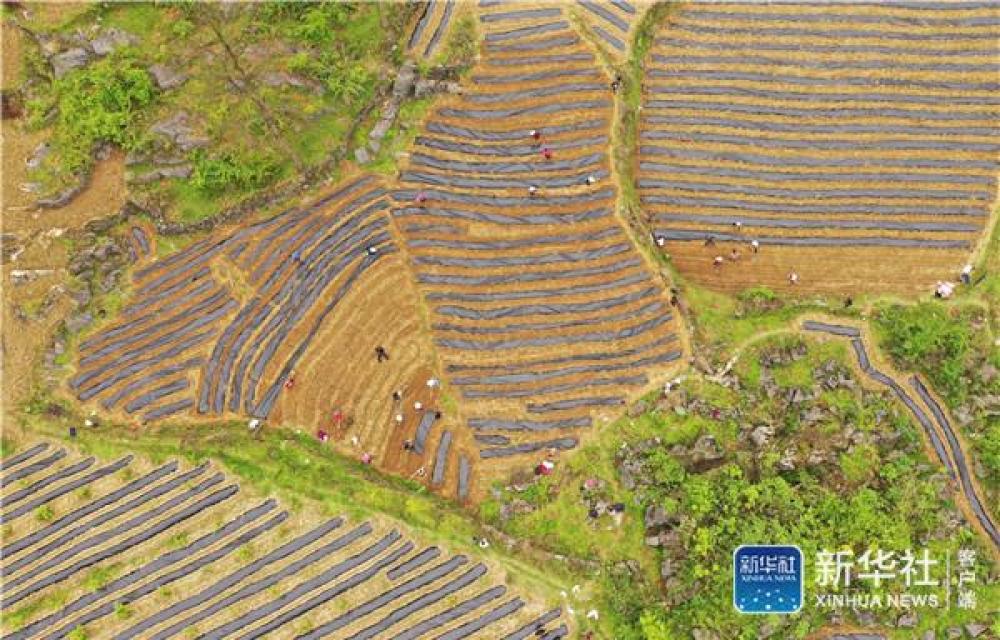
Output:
640,2,1000,292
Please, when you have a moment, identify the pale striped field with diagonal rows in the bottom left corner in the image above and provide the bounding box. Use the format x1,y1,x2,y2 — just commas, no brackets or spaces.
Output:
0,444,568,640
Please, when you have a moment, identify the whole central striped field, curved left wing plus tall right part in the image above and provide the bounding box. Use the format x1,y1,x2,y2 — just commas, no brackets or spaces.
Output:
70,2,682,499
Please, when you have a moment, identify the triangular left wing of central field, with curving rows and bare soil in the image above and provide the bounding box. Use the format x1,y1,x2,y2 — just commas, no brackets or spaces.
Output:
70,178,442,470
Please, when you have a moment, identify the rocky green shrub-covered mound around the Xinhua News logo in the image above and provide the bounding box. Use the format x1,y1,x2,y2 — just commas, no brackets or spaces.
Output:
480,338,1000,640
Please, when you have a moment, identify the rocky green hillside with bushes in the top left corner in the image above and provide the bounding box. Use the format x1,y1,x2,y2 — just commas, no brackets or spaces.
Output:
12,2,410,221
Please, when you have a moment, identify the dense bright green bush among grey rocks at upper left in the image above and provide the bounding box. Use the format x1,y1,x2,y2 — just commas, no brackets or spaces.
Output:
47,58,156,172
